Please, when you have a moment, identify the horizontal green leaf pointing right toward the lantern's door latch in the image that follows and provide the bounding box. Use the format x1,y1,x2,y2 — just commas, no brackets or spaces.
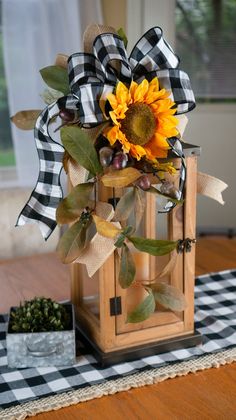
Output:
128,236,178,256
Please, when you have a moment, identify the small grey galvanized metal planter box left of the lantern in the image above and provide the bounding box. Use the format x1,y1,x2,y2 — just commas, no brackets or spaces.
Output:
6,303,76,368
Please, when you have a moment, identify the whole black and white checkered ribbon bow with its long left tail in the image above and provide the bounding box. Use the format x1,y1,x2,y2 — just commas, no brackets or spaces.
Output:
17,27,195,239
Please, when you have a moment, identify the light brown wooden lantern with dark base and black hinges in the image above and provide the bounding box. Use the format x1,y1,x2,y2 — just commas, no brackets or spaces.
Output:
71,145,200,365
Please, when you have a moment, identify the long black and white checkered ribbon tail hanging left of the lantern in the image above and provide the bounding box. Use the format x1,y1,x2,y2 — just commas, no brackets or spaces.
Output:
16,102,64,240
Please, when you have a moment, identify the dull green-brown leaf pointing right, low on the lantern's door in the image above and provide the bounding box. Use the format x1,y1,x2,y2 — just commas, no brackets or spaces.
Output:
152,283,187,311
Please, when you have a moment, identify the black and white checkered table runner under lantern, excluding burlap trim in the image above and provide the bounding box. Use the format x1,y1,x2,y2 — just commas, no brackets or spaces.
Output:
0,270,236,410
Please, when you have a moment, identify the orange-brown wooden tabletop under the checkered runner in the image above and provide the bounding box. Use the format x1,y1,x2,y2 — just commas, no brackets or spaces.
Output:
0,238,236,420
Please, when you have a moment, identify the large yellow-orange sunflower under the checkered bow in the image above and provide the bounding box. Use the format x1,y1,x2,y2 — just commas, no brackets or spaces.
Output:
104,77,178,161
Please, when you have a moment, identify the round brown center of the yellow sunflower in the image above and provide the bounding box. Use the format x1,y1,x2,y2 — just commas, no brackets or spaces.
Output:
121,104,156,146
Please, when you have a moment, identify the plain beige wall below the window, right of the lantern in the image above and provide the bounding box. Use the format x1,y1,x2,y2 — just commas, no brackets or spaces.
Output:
184,104,236,228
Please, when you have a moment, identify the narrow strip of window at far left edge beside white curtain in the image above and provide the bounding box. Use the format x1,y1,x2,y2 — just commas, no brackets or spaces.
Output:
0,1,15,170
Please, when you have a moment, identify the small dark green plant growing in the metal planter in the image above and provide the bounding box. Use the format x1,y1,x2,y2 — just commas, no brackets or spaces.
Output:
9,297,70,332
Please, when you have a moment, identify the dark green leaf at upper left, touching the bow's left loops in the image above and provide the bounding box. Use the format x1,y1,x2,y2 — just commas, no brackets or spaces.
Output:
40,66,70,95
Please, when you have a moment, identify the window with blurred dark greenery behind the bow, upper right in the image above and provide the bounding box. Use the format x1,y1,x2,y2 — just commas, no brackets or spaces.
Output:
175,0,236,102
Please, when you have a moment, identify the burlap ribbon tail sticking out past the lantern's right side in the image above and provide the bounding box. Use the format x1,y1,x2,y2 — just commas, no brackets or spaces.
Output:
197,172,228,205
